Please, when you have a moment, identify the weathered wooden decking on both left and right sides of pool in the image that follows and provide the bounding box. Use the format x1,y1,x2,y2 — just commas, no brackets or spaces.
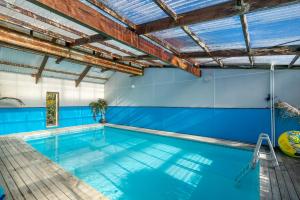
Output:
0,134,300,200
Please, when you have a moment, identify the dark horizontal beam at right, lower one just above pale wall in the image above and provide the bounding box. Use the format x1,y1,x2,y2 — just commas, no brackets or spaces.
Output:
181,45,300,58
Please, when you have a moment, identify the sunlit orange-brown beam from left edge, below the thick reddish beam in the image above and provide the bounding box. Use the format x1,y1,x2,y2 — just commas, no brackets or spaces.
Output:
0,27,143,75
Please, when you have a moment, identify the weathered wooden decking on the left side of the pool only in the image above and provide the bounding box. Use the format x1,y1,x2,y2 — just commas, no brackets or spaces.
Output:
0,137,106,200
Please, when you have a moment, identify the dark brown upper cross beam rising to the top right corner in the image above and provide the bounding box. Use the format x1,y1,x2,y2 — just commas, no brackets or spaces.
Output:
136,0,297,34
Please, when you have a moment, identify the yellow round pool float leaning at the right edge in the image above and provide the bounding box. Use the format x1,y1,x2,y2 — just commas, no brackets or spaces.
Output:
278,131,300,158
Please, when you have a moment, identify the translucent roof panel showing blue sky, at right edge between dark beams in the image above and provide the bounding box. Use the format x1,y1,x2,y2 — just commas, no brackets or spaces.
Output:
247,4,300,47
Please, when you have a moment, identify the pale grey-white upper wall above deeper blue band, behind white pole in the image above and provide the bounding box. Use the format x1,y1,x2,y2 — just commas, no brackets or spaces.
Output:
105,69,300,108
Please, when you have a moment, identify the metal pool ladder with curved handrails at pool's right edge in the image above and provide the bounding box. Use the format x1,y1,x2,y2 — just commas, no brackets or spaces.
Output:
234,133,279,184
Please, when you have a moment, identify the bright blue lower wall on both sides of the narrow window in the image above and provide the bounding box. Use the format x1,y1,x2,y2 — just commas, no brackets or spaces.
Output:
0,106,99,135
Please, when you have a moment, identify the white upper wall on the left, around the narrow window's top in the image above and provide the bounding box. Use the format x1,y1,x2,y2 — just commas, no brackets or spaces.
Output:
0,72,104,107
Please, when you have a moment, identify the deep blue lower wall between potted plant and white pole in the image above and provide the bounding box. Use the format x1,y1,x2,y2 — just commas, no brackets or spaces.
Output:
107,106,271,143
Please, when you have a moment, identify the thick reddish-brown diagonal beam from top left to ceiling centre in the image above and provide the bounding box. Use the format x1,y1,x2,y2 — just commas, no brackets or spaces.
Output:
29,0,200,76
